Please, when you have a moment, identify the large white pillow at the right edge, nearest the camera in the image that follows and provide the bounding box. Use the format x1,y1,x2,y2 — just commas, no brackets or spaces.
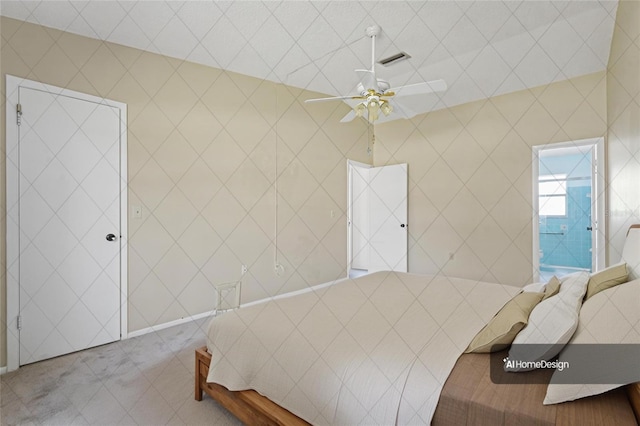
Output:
544,280,640,405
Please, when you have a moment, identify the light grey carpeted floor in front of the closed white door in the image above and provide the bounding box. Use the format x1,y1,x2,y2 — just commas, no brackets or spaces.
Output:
0,319,241,425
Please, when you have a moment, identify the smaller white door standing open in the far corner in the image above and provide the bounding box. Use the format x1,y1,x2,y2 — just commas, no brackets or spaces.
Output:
368,164,408,272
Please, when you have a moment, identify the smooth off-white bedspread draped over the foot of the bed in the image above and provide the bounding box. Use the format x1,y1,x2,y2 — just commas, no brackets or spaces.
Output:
207,272,519,425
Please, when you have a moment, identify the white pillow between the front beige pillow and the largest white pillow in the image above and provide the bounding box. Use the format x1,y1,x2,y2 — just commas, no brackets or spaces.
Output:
509,272,589,371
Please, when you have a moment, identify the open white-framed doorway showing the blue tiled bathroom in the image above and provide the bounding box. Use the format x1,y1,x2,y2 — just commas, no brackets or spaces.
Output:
533,138,605,281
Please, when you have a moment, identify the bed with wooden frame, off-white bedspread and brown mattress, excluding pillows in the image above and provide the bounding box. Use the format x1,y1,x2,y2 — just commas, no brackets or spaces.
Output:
195,226,640,425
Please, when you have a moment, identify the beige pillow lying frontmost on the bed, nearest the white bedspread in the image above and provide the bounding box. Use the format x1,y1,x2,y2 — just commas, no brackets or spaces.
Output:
465,293,544,353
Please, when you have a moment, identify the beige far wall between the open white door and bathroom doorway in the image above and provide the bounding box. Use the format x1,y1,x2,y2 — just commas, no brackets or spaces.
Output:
374,72,606,286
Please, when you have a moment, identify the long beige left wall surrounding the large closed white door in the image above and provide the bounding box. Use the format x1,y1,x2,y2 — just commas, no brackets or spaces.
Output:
0,17,371,365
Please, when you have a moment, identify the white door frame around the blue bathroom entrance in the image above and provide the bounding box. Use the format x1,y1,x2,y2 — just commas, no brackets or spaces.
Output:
531,137,607,281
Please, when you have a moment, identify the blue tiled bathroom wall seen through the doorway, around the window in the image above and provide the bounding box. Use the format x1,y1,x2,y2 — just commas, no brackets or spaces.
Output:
540,154,591,269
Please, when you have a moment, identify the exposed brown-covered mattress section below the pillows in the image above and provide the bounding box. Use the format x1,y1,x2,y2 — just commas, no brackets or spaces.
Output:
431,351,637,426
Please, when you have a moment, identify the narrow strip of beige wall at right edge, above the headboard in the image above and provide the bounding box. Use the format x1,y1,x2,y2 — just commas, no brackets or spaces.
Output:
607,1,640,263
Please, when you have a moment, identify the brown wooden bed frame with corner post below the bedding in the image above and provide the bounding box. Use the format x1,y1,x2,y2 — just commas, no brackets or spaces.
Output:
195,346,640,426
